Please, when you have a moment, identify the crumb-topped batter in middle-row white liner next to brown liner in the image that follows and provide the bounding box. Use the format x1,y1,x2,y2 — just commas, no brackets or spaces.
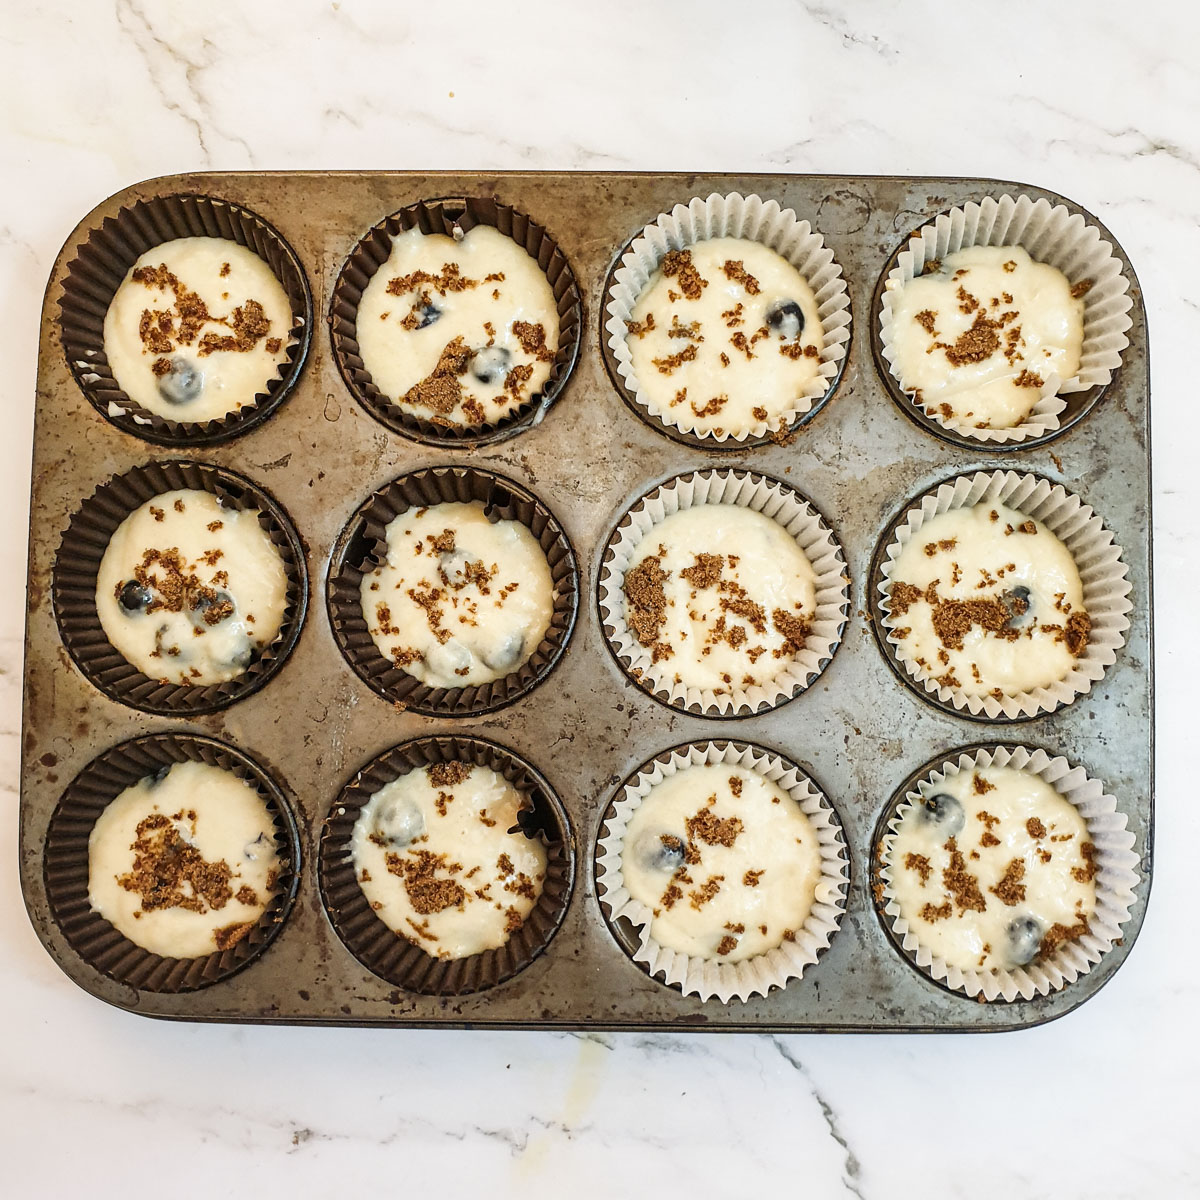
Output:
623,504,816,695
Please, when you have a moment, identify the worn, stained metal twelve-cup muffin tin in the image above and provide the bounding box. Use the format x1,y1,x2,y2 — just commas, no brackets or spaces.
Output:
20,172,1153,1032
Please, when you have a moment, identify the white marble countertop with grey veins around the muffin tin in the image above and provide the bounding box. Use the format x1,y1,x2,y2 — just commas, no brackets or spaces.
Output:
0,0,1200,1198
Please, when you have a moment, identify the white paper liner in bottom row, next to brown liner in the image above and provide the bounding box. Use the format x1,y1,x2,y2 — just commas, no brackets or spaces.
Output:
595,742,850,1004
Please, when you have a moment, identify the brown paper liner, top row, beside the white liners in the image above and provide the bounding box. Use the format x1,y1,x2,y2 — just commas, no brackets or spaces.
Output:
329,196,583,448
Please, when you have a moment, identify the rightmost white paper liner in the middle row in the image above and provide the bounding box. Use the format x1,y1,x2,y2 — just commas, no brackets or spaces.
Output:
868,470,1133,721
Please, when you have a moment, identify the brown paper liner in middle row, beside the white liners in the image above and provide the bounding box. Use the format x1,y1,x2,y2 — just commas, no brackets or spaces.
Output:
328,467,580,716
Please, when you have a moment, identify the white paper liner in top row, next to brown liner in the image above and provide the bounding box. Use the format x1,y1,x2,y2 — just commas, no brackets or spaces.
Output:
605,192,850,442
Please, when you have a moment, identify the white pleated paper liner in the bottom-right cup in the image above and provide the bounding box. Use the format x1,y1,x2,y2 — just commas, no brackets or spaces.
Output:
880,746,1140,1001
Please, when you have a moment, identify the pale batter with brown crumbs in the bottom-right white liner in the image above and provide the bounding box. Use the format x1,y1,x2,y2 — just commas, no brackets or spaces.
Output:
886,767,1097,971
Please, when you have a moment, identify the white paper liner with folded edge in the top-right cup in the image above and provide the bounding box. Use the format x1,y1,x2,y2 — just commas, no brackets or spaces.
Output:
880,193,1133,443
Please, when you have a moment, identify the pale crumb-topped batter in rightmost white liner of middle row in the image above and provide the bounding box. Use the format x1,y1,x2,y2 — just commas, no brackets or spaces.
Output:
884,502,1091,698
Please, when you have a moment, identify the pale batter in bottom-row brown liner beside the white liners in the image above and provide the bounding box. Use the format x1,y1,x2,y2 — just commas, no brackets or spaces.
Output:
350,762,546,959
